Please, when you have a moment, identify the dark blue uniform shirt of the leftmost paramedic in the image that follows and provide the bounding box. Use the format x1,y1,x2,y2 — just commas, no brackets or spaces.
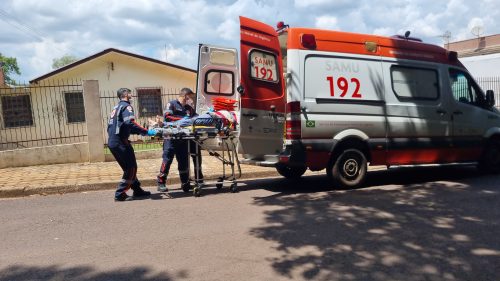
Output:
108,100,148,140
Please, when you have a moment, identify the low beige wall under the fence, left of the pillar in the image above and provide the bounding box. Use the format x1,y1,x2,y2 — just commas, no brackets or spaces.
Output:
0,143,89,169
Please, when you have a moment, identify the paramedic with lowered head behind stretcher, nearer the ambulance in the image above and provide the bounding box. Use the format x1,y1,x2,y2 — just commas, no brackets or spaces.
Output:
157,88,203,192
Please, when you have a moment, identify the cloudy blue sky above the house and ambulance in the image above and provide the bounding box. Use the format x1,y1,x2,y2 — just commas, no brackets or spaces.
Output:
0,0,500,82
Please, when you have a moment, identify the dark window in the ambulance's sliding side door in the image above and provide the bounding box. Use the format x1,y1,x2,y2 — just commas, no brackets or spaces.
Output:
391,65,439,100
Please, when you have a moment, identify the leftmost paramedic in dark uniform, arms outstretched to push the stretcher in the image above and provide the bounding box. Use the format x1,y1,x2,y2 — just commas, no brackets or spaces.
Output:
108,88,156,201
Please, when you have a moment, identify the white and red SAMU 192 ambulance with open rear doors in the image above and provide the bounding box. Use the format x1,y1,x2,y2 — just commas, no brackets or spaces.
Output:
197,17,500,188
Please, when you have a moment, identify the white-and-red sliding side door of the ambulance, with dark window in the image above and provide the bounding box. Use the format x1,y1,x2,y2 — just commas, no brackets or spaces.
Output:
384,63,453,165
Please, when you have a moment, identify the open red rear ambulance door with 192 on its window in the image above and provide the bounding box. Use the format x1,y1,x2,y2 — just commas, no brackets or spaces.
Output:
240,17,286,163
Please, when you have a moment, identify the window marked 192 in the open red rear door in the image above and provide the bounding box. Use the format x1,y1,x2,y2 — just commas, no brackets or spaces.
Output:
250,49,278,83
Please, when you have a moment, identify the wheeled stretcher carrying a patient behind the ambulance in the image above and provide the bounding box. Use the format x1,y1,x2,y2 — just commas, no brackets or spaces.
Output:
155,118,241,197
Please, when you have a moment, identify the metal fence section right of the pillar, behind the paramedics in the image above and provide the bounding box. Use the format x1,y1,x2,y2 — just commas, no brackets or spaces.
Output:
100,87,180,154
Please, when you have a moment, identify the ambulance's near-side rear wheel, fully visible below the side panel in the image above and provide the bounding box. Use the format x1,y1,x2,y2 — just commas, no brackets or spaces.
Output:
327,148,368,189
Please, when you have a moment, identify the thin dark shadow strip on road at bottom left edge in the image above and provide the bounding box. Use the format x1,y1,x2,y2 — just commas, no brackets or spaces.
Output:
0,266,186,281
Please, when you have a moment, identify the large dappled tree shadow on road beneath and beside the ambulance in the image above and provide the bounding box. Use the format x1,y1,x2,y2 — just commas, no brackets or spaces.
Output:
248,166,500,280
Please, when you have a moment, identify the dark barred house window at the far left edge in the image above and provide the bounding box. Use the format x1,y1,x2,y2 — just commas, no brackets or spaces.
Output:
2,95,33,128
